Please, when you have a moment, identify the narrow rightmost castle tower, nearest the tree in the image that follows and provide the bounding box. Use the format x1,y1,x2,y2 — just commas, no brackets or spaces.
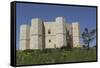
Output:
72,22,80,47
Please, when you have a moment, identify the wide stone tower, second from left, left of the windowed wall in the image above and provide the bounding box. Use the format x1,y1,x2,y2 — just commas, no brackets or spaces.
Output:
30,18,43,49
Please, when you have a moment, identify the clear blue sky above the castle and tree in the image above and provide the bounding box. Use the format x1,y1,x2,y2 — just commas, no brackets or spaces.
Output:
16,3,96,48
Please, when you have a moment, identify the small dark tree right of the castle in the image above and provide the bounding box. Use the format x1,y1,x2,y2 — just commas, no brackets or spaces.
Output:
82,28,96,49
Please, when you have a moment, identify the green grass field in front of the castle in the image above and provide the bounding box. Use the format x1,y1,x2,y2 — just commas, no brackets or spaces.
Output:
16,48,96,65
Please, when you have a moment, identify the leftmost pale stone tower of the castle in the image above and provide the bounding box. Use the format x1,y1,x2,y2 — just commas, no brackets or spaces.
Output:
19,24,30,50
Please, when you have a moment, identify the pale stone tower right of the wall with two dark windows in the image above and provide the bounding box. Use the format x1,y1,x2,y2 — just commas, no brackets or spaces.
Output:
55,17,67,48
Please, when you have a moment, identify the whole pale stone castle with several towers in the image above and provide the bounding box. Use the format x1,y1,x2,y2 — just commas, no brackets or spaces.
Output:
19,17,81,50
